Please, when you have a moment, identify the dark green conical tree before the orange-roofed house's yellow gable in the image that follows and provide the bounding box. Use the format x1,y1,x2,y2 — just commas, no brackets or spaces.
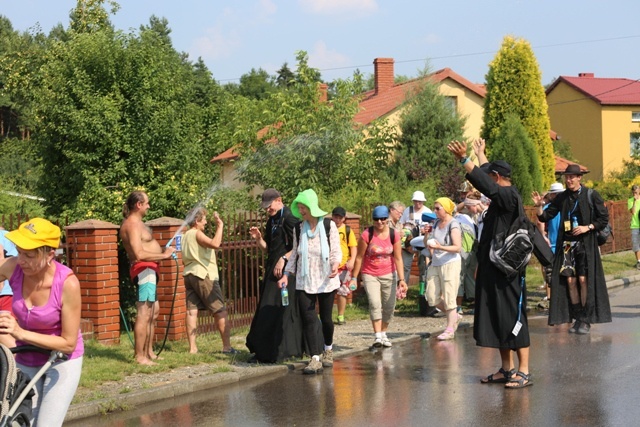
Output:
395,79,465,189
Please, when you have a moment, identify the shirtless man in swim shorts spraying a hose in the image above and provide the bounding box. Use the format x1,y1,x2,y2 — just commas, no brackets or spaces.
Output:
120,191,175,365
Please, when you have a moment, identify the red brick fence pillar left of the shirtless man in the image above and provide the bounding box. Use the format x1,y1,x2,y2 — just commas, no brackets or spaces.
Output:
65,220,120,344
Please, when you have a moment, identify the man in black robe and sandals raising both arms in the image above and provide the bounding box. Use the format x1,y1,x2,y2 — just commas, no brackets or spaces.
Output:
447,139,533,388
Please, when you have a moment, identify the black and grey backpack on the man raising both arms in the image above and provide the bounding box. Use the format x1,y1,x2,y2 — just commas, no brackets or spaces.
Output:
489,198,536,279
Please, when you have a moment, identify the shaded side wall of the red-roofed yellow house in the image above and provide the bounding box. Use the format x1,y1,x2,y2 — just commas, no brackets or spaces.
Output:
547,82,603,180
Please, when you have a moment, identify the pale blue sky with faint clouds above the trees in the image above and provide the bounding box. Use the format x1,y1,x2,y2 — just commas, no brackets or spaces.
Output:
0,0,640,85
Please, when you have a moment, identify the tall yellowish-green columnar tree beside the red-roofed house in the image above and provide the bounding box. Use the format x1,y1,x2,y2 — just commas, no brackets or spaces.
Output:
482,36,555,186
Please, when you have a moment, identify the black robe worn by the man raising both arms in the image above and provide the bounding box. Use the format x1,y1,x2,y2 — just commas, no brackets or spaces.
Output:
467,167,530,350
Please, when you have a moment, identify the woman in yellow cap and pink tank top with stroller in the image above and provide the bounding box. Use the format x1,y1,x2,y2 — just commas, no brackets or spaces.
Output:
0,218,84,426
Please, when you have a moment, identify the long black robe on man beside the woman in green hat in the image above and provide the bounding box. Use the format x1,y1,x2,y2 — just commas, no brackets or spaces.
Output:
246,207,303,363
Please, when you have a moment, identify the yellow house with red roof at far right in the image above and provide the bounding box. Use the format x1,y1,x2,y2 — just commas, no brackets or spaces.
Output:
547,73,640,180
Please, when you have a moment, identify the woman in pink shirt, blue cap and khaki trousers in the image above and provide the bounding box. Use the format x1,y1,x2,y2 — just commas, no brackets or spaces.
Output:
351,206,407,348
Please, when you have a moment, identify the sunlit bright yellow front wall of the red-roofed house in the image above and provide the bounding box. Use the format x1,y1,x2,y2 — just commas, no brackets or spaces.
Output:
602,105,640,176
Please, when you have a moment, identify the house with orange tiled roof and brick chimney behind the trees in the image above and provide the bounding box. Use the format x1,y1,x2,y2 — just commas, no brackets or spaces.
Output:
211,58,486,191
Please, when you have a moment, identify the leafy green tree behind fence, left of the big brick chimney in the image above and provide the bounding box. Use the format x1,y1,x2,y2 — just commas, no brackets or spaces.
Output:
239,52,392,200
